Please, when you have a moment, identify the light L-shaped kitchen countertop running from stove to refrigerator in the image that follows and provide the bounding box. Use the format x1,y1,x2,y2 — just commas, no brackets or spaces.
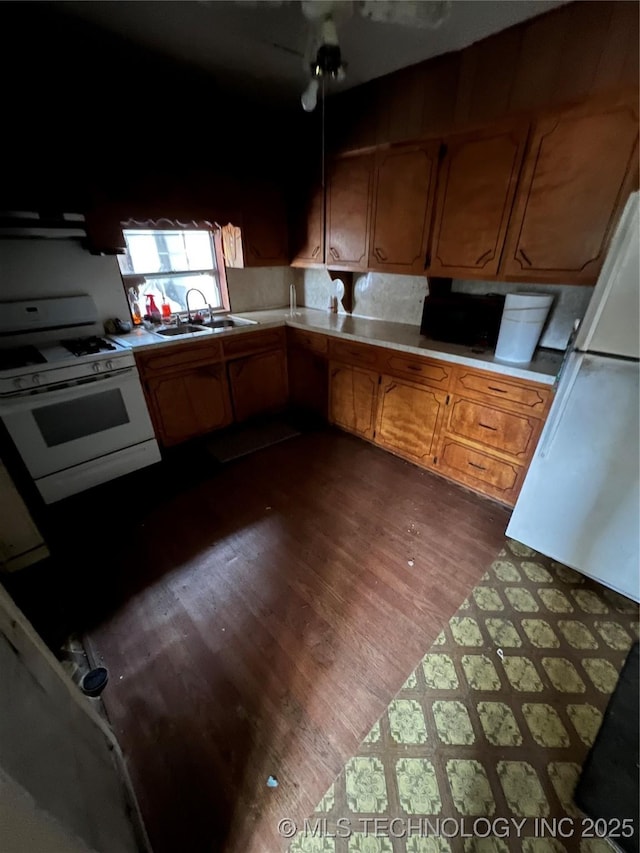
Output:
111,308,564,385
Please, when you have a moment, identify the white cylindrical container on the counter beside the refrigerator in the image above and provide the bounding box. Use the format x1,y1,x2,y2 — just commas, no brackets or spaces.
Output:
496,293,553,364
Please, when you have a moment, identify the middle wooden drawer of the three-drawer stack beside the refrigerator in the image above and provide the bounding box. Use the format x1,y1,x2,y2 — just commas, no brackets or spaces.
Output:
447,397,541,460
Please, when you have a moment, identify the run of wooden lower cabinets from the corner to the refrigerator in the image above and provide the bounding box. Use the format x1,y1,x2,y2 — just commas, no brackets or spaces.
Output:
329,338,552,506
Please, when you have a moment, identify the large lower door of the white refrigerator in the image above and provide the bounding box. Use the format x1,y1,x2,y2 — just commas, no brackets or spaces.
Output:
507,353,640,601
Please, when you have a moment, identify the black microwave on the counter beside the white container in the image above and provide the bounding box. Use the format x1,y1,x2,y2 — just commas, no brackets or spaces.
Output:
420,293,505,349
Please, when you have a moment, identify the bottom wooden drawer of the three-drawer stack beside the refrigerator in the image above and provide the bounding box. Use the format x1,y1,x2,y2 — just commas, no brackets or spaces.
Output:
437,438,525,506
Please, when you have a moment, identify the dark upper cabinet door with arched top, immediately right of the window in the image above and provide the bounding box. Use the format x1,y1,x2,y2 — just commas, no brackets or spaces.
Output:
242,183,289,267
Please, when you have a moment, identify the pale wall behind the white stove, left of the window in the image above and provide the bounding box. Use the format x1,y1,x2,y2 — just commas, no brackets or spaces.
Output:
0,239,129,321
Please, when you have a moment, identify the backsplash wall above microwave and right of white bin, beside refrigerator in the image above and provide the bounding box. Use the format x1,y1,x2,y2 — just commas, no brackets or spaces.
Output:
452,280,593,350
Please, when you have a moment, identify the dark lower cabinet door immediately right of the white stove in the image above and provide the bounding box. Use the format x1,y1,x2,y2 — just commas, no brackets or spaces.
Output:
147,364,232,447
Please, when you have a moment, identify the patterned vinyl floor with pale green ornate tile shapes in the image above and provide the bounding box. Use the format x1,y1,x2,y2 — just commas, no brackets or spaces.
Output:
289,541,638,853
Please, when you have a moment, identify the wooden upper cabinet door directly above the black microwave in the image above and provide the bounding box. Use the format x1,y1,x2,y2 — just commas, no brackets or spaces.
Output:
429,123,527,278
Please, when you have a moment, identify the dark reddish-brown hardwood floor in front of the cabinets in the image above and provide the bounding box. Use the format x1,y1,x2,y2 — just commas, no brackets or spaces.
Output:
76,431,507,853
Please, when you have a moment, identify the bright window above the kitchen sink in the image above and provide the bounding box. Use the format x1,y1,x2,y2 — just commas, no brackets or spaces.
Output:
118,228,229,321
